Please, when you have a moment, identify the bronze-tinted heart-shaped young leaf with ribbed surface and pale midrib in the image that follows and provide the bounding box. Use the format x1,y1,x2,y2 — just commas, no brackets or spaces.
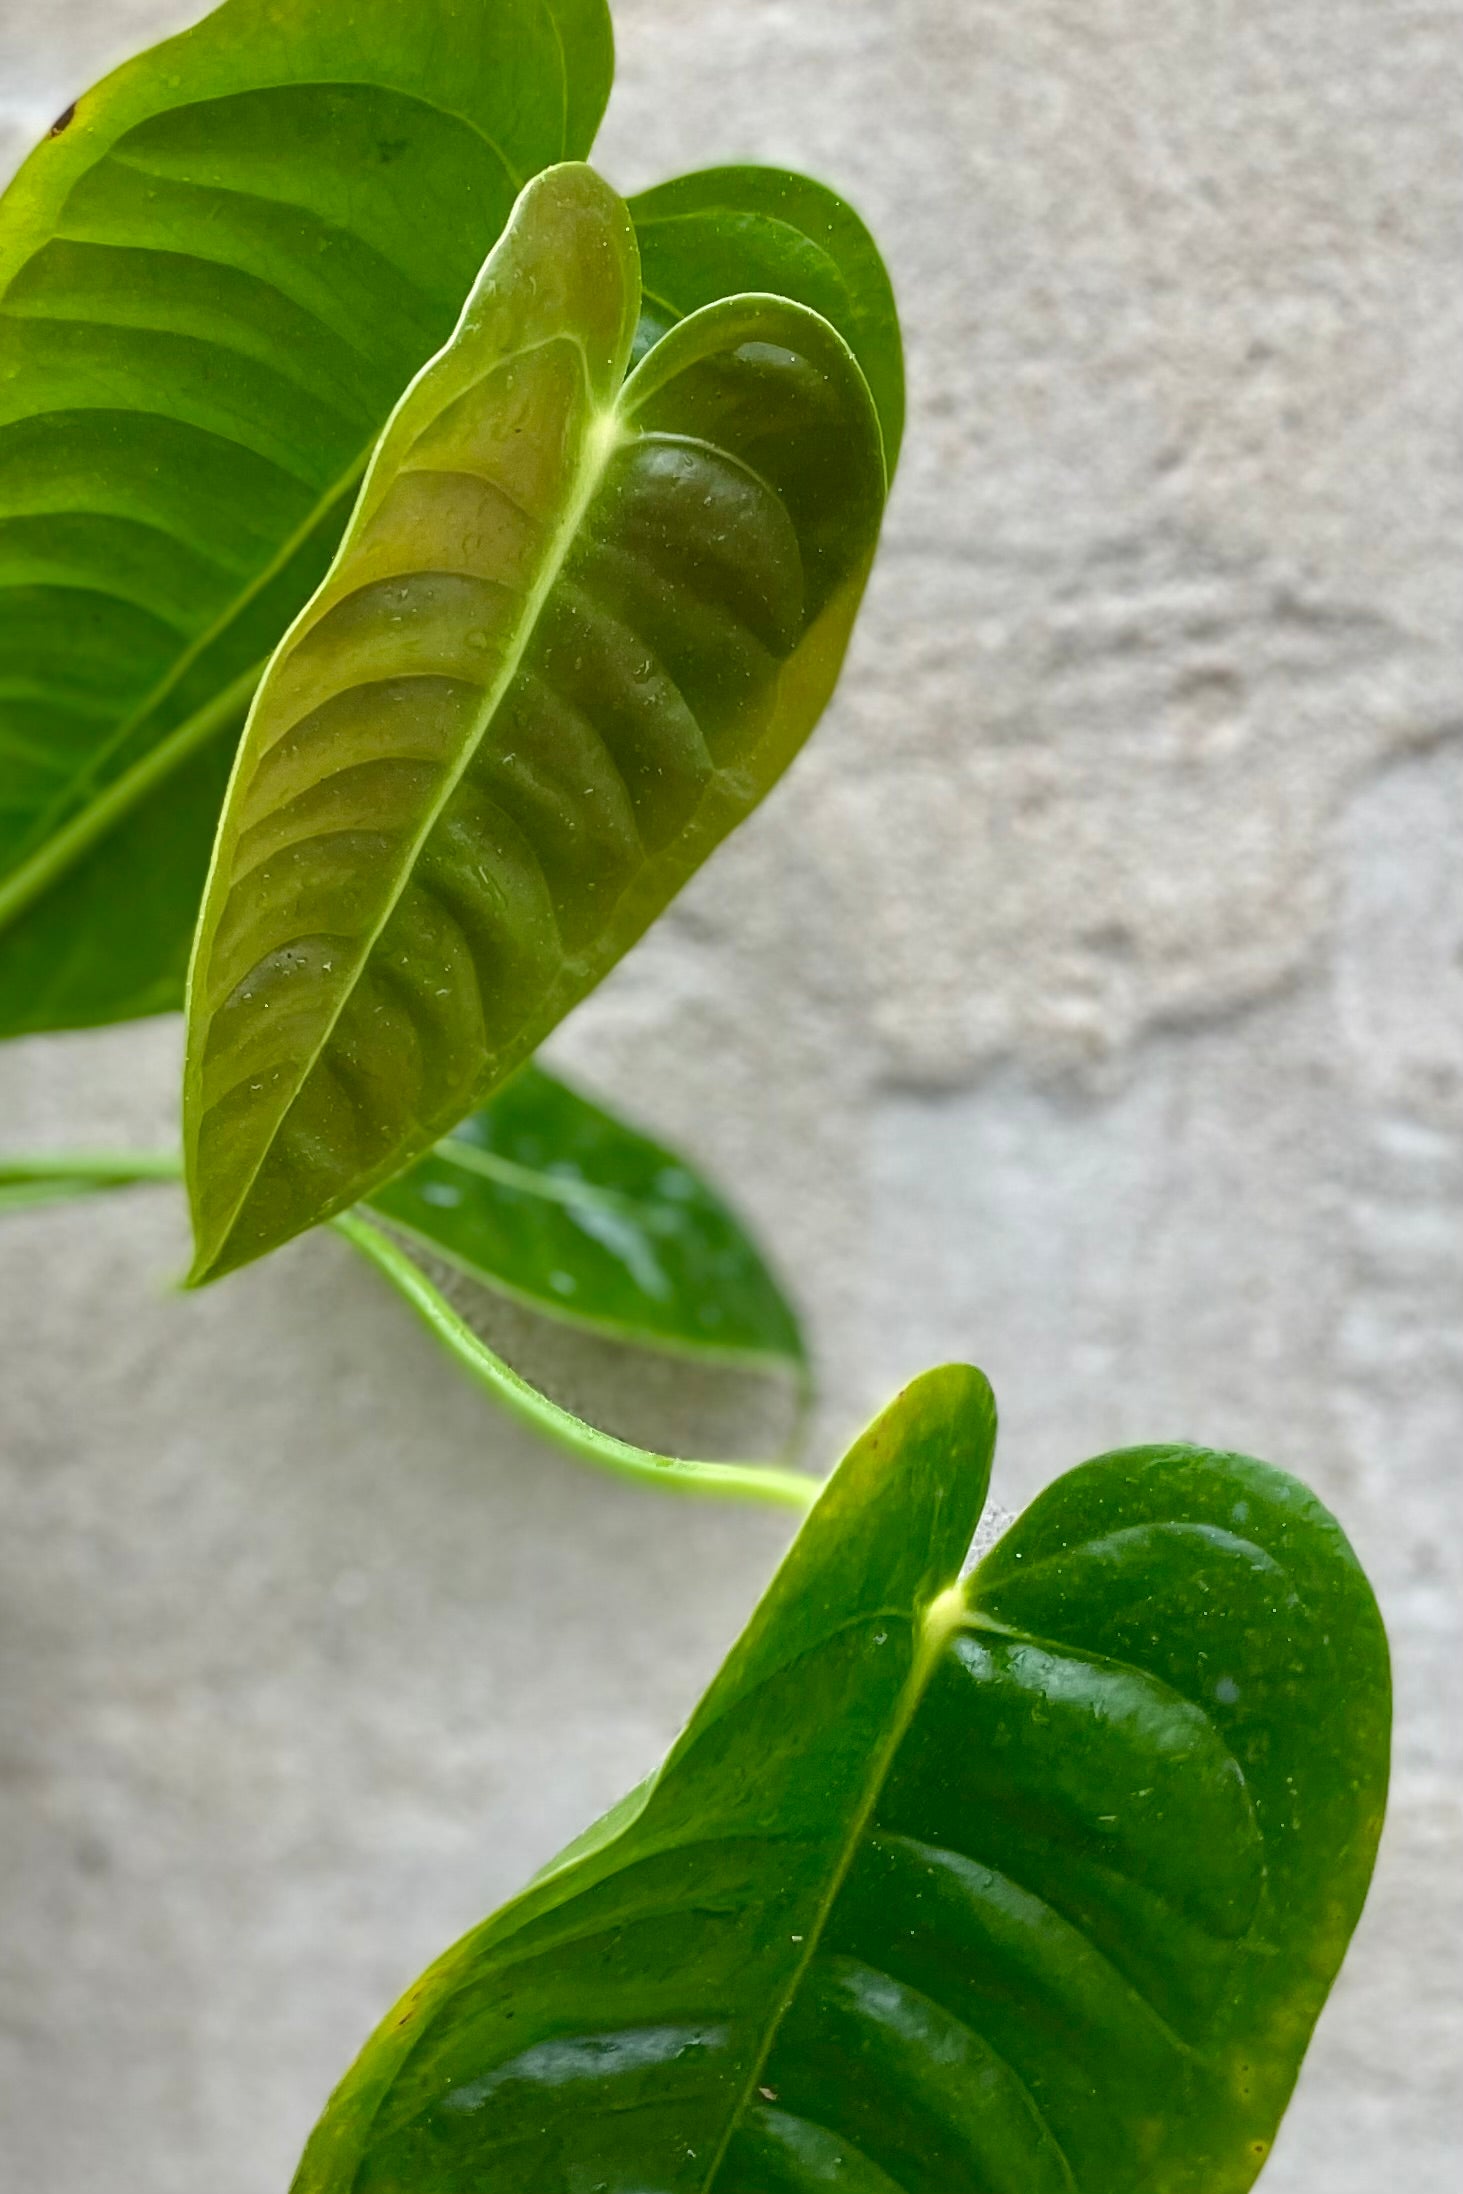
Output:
184,165,884,1281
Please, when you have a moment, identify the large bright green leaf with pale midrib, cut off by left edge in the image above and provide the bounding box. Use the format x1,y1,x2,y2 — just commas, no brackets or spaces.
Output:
0,0,612,1036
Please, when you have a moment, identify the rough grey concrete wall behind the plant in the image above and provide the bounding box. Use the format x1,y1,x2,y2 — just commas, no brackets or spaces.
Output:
0,0,1463,2194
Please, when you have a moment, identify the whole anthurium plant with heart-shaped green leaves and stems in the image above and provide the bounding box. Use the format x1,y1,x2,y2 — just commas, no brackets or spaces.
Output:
0,0,1388,2194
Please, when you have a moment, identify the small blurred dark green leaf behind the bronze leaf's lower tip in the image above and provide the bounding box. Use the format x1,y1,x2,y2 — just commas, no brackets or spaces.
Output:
364,1066,807,1369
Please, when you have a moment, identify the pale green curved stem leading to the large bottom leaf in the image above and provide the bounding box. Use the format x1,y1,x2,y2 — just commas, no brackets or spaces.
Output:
333,1211,823,1509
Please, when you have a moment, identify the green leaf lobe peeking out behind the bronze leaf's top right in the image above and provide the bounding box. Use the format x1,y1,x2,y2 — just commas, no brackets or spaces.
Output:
630,167,904,480
